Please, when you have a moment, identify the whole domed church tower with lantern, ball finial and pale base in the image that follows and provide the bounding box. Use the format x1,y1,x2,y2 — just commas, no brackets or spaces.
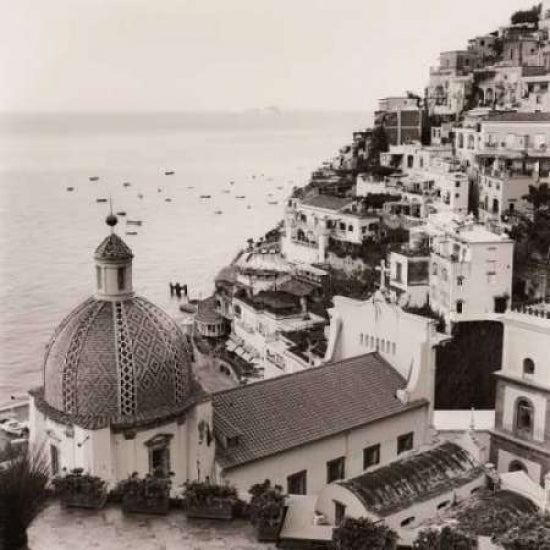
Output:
30,216,214,484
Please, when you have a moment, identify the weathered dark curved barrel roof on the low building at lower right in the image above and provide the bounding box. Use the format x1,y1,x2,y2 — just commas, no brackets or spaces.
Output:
338,441,483,517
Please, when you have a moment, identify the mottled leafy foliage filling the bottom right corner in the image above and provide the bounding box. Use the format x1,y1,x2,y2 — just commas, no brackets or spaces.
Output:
493,513,550,550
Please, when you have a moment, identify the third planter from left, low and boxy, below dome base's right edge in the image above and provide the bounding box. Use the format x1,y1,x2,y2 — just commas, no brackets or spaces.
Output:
183,480,238,519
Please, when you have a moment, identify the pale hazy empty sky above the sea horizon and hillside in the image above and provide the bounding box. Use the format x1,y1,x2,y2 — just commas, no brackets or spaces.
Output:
0,0,535,112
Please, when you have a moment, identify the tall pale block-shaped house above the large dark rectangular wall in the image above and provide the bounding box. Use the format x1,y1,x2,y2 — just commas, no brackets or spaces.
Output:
430,222,514,323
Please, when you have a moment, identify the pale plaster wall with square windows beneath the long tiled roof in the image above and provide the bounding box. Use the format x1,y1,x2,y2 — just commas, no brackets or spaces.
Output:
224,406,428,494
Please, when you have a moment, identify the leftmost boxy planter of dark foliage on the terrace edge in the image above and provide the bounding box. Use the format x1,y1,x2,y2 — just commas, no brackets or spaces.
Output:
53,468,107,510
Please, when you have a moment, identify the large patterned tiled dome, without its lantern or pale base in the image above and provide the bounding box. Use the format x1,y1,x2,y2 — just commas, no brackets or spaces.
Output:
44,296,191,424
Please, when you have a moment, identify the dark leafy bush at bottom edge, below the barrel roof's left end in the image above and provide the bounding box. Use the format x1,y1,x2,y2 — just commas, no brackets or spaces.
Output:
332,518,397,550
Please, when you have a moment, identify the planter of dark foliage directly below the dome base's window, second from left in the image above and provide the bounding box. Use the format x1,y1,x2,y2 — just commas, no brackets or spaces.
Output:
115,472,172,514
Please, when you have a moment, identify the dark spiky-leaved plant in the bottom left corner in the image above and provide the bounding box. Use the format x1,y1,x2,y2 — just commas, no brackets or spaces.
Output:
0,451,49,550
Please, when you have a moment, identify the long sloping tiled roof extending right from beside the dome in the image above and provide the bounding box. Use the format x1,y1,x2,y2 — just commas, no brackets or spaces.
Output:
212,353,428,468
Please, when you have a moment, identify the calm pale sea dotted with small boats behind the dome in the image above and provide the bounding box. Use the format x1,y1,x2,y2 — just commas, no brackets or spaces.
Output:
0,113,369,403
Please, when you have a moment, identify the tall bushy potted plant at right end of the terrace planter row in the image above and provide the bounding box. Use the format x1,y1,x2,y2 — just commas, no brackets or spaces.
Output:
248,479,287,542
